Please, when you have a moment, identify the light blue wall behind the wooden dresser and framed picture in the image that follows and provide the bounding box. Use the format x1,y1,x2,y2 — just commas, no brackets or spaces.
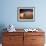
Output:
0,0,46,44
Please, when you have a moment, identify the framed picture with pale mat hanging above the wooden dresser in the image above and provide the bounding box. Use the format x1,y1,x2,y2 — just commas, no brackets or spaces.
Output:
17,7,35,22
